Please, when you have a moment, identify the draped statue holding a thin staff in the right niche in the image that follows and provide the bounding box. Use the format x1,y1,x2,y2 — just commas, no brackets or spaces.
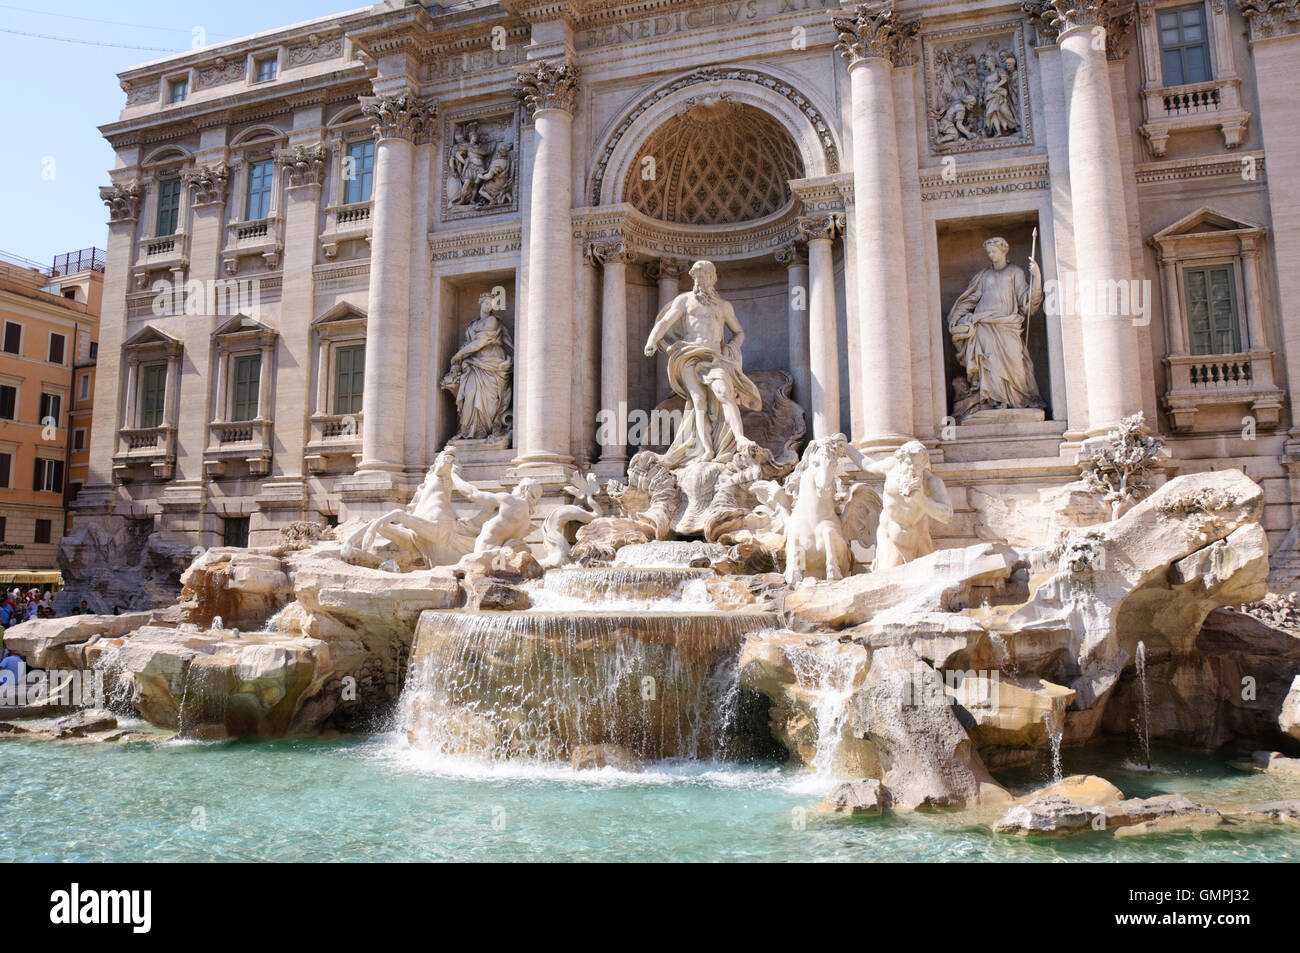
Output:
948,238,1047,420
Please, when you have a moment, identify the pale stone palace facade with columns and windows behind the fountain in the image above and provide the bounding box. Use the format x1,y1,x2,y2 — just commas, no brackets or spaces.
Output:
69,0,1300,558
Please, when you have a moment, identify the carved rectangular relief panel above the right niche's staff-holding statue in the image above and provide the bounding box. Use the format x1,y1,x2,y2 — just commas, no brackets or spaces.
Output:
931,39,1023,147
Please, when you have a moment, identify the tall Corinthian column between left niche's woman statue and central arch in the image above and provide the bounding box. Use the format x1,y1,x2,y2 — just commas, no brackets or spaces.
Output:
515,61,579,476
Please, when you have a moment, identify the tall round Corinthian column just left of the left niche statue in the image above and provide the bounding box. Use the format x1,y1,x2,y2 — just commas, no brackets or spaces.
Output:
361,92,437,471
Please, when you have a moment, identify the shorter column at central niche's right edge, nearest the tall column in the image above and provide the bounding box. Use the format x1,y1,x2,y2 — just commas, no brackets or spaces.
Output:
800,215,844,437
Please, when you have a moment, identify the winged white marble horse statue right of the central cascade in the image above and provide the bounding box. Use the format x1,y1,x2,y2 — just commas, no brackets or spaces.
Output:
757,433,881,586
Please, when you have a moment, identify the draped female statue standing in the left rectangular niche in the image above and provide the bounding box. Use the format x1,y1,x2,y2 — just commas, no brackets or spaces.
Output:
442,293,512,439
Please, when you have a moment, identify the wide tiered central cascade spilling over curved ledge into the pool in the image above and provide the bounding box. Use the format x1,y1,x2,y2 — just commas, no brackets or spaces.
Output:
399,543,775,761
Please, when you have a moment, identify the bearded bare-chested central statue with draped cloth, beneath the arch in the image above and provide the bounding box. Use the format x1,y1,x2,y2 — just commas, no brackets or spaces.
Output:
645,261,762,468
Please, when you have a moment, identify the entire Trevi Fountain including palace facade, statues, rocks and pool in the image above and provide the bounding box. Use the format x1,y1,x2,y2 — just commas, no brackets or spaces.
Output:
0,0,1300,863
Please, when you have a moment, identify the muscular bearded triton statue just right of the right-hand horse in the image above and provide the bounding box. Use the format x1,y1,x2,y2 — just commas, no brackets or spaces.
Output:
859,441,953,572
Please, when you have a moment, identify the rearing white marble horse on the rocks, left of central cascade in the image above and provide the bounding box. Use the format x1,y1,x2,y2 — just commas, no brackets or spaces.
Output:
342,447,473,568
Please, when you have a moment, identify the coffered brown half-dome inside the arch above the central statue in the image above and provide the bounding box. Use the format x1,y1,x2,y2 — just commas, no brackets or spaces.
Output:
623,94,803,225
